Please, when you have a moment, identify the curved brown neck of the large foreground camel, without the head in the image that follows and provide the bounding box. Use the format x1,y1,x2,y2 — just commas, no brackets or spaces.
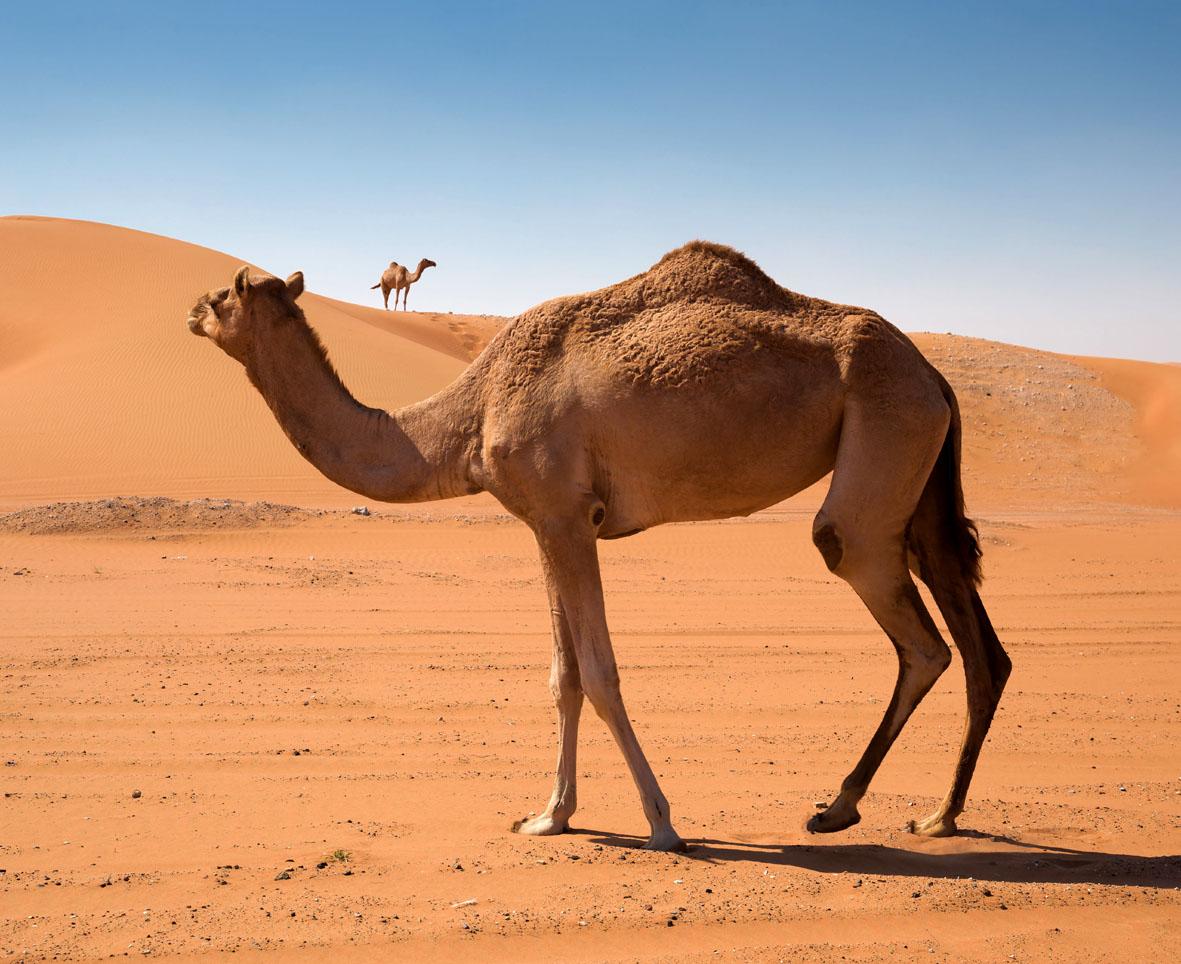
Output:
246,318,478,502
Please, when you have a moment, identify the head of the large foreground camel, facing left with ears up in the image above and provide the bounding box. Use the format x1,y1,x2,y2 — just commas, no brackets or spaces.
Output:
189,265,304,364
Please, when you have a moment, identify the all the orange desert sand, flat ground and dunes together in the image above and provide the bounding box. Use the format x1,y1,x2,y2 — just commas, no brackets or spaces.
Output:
0,217,1181,960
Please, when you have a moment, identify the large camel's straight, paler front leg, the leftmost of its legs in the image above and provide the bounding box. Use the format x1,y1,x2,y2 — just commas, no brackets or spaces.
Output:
513,555,582,836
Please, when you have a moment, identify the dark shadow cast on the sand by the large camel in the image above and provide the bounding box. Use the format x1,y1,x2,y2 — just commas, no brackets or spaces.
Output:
569,828,1181,887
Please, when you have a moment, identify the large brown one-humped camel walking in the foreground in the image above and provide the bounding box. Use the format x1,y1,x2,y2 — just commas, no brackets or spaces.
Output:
188,241,1011,851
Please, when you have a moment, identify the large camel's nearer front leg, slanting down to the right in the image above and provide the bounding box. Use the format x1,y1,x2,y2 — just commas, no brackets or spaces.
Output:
535,516,685,851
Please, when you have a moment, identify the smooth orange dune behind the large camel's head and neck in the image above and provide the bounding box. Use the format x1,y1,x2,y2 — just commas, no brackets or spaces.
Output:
0,217,465,507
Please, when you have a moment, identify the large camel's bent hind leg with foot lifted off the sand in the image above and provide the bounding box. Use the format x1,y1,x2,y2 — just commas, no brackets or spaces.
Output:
808,399,951,833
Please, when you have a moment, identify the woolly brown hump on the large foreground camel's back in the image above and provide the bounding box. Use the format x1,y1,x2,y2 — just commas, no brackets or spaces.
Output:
635,241,790,308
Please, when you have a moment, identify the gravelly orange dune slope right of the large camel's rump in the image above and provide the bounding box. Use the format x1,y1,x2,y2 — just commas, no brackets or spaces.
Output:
912,333,1181,508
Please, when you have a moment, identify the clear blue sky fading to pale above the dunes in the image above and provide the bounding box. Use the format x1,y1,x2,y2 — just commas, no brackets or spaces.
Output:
0,0,1181,360
